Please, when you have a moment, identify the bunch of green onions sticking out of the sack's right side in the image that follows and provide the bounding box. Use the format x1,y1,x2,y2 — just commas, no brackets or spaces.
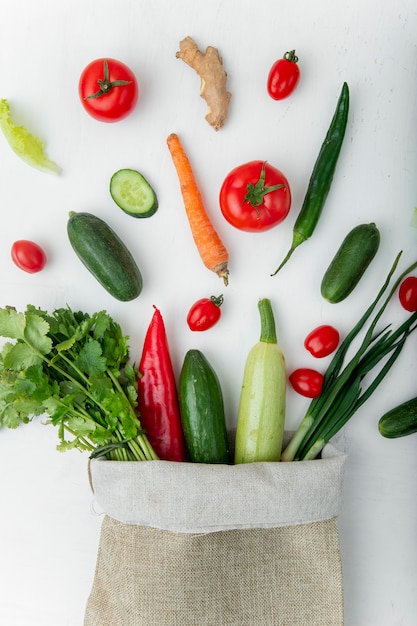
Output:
281,252,417,461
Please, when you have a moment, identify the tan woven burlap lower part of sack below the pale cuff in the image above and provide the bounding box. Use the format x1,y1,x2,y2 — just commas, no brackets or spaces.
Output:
84,516,343,626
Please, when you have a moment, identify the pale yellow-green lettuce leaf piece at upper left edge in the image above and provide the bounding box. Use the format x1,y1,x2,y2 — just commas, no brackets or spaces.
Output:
0,98,61,174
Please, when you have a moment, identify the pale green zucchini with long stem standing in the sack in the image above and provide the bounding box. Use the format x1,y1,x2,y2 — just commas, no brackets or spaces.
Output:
235,298,287,463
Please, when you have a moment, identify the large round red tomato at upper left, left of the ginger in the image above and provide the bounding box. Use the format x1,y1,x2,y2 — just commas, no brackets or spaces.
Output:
78,59,139,122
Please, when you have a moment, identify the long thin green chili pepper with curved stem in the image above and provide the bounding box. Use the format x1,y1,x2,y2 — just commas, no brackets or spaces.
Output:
271,83,349,276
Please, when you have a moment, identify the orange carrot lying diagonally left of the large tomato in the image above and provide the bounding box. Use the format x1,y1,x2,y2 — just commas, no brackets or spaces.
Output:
167,133,229,285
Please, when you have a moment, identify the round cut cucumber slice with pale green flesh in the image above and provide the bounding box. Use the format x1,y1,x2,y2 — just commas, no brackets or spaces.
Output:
110,169,158,217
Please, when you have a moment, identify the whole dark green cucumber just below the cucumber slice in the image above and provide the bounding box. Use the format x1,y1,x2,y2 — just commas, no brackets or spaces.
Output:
67,211,143,302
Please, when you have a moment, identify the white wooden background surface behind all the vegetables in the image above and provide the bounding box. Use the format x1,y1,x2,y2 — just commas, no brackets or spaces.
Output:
0,0,417,626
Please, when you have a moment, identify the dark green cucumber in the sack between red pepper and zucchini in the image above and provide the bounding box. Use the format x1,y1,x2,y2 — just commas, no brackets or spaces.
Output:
178,350,230,463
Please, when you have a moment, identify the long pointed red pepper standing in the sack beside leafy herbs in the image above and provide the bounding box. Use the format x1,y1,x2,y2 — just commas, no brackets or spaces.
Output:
138,306,186,461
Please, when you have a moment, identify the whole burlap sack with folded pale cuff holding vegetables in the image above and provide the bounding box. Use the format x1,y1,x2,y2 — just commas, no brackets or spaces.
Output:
84,445,345,626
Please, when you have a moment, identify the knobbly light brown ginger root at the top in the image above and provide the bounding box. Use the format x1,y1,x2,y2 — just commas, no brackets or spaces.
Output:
176,37,232,131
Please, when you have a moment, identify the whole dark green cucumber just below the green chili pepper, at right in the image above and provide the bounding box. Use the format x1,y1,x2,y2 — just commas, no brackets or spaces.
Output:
321,222,380,303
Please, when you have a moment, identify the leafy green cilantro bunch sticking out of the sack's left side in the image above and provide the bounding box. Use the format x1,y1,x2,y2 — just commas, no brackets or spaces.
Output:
0,305,157,461
